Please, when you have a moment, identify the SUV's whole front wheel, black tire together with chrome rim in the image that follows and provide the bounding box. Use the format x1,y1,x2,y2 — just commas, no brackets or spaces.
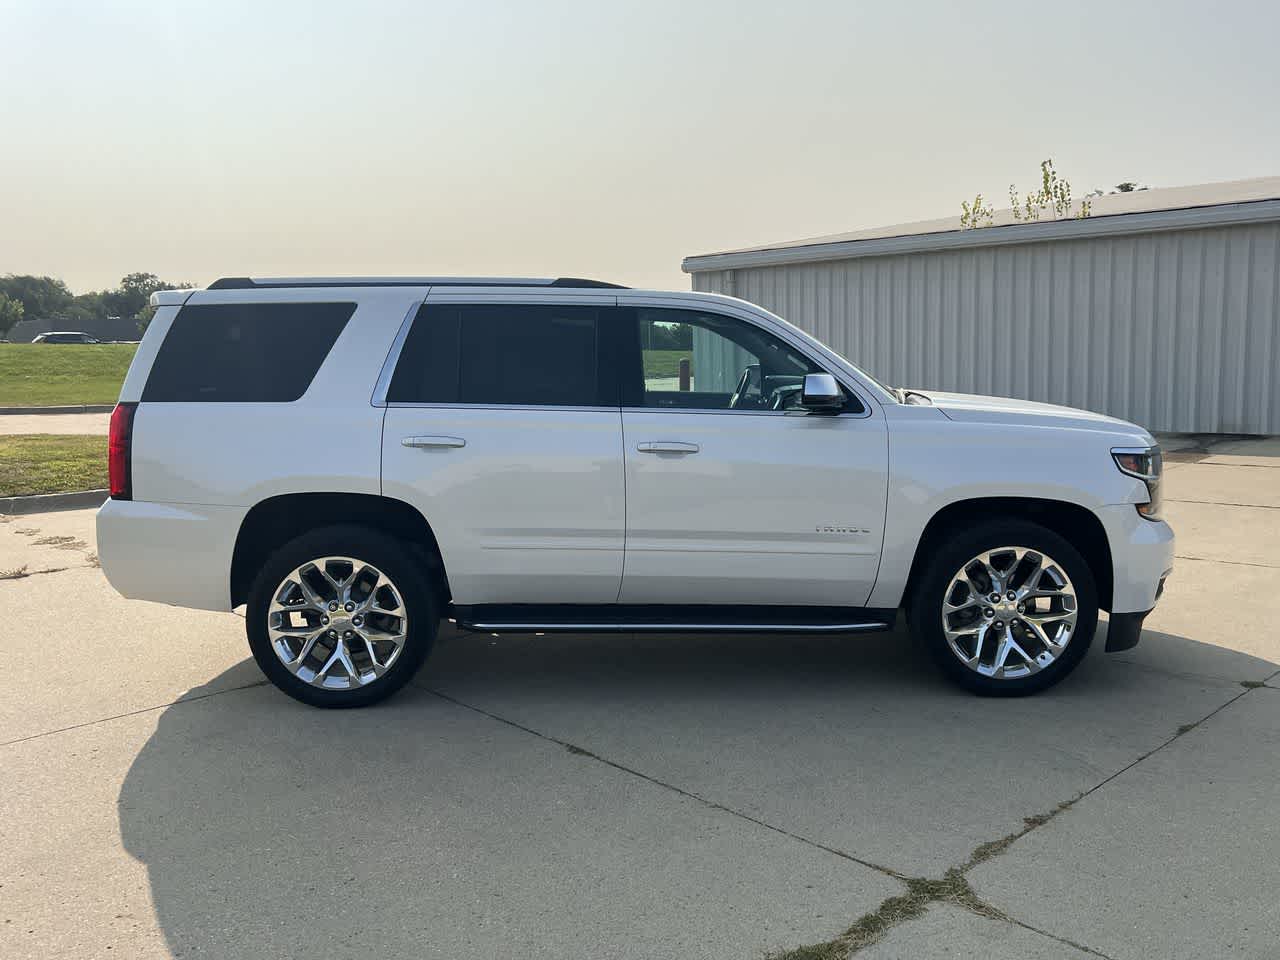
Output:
910,521,1098,696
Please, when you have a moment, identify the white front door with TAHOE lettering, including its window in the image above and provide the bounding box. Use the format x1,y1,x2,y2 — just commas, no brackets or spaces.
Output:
620,307,888,607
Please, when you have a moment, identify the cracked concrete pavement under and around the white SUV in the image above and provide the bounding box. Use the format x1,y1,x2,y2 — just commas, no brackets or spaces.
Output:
0,440,1280,960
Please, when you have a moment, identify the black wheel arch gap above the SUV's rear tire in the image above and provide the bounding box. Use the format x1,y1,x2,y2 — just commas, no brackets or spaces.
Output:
230,493,452,608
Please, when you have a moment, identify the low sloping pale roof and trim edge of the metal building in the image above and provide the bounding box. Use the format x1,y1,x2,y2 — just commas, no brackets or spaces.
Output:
681,177,1280,273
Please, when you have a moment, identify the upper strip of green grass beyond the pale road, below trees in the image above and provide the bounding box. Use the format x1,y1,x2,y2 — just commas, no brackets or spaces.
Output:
0,343,137,407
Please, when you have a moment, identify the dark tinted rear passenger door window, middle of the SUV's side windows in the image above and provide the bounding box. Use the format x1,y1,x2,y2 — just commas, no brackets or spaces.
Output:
387,303,601,407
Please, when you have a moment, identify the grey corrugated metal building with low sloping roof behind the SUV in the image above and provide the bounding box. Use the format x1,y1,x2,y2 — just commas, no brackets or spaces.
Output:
684,177,1280,434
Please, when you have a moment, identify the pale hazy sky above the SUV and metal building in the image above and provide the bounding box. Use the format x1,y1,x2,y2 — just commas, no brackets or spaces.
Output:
0,0,1280,293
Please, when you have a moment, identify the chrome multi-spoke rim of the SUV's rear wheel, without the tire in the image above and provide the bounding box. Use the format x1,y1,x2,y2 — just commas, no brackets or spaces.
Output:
266,557,408,690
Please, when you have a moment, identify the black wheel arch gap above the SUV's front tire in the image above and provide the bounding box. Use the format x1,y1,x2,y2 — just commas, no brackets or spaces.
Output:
902,497,1115,611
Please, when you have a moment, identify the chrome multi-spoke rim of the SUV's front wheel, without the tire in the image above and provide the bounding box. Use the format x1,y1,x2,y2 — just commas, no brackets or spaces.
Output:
942,547,1079,680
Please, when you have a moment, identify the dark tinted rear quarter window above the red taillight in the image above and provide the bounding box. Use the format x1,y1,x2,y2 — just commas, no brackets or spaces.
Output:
142,303,356,403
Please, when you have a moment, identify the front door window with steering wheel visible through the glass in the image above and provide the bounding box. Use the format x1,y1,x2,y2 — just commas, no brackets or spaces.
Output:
635,310,849,411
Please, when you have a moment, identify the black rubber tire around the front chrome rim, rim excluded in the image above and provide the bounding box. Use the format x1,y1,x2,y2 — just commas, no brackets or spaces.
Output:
908,520,1098,696
